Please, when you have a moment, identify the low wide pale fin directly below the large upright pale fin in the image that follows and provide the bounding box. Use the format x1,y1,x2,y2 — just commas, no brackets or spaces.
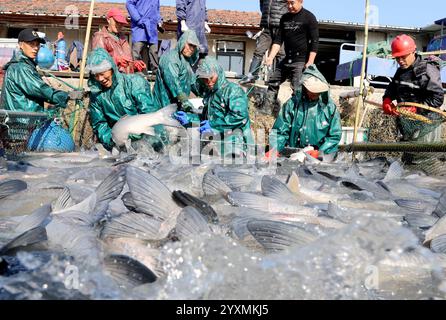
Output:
101,212,161,241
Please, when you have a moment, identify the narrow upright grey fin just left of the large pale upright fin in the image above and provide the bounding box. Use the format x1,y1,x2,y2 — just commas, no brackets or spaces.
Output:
95,167,126,212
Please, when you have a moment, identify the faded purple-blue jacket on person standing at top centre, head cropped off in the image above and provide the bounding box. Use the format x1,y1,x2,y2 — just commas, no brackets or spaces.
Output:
176,0,208,53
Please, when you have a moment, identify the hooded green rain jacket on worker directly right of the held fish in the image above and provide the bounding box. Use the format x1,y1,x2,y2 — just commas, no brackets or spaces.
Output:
188,57,254,150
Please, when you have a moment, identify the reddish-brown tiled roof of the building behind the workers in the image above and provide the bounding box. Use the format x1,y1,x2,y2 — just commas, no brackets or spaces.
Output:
0,0,260,26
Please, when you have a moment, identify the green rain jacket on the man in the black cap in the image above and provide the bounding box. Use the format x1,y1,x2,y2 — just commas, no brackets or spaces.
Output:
0,50,68,112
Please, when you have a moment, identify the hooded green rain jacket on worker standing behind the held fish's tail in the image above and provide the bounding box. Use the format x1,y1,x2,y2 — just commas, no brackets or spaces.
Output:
153,30,200,107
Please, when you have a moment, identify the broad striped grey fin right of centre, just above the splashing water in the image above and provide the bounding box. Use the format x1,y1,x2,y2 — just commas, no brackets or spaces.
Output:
248,220,316,251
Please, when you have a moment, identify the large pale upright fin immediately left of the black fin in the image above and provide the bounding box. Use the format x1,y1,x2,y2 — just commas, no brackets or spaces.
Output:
127,166,180,220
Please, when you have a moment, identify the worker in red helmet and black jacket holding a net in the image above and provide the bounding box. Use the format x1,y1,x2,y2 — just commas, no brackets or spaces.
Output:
382,34,446,173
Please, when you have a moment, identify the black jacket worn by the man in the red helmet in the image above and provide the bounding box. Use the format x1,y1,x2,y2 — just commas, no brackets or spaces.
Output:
384,55,444,114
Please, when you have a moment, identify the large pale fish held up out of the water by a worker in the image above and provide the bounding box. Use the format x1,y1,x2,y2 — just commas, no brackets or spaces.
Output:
112,104,181,147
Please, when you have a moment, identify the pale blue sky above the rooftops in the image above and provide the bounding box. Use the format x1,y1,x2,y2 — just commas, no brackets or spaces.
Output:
108,0,446,27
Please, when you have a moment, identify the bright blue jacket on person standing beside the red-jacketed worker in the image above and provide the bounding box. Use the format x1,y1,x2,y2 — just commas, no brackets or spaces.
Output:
126,0,162,44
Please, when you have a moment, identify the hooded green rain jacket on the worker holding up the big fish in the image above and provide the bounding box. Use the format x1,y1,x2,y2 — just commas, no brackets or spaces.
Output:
87,48,159,149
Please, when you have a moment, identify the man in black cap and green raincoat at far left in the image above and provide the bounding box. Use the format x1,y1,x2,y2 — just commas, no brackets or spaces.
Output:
0,29,83,112
